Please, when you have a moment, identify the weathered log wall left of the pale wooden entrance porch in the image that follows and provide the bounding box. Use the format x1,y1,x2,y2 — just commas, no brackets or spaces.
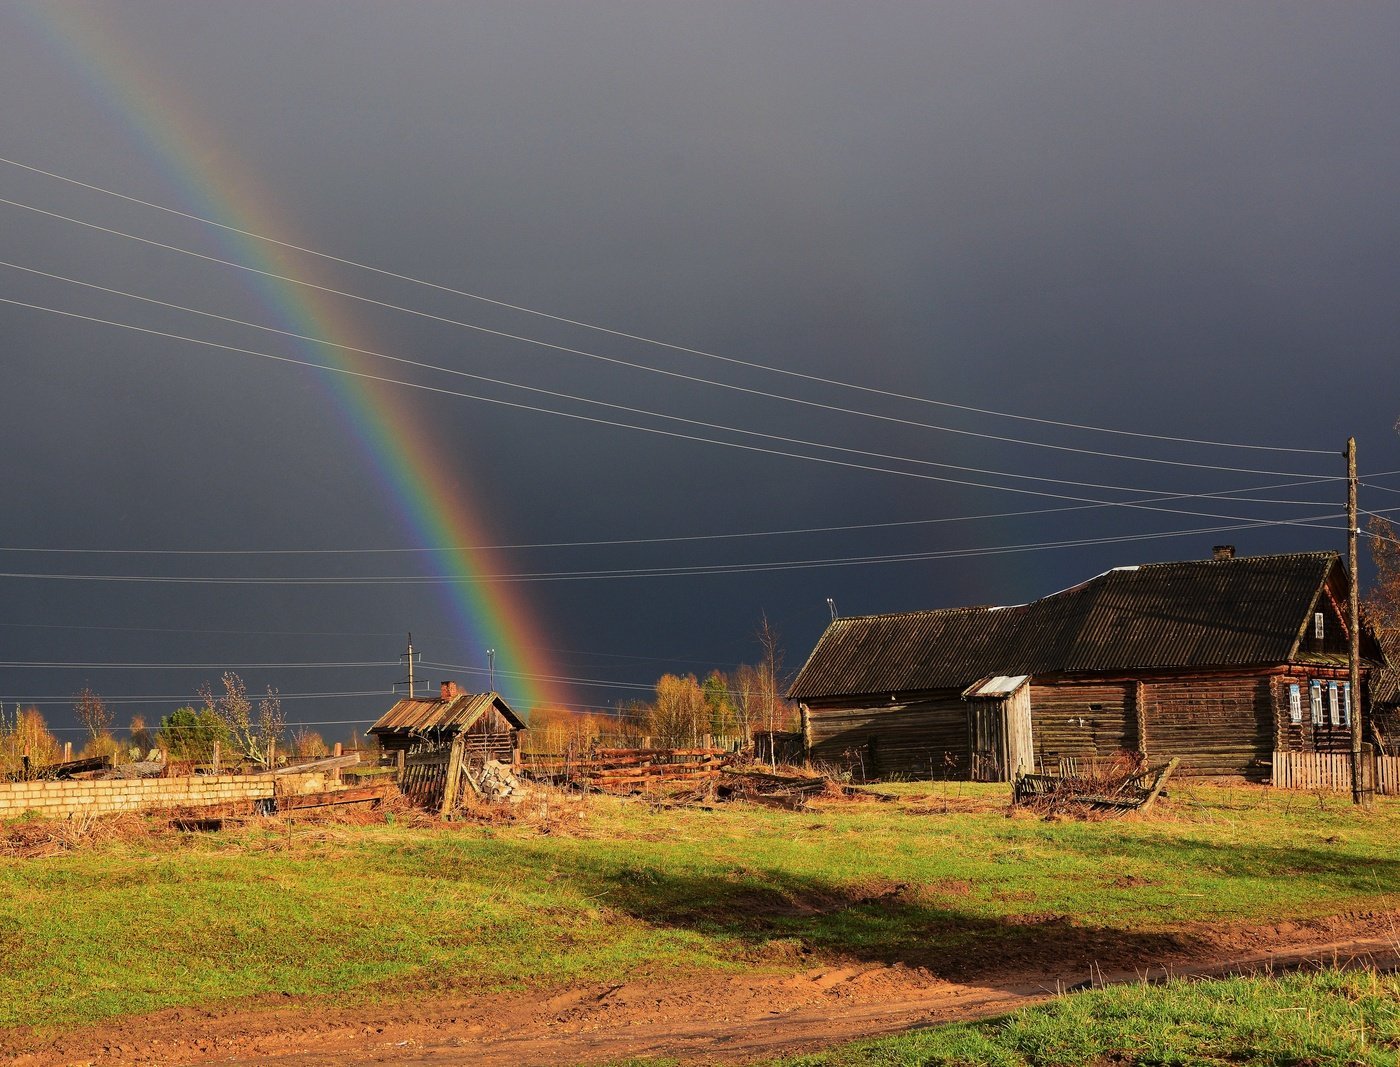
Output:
806,690,969,779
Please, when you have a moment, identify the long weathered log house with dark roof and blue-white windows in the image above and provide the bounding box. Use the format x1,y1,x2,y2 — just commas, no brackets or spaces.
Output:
788,546,1386,780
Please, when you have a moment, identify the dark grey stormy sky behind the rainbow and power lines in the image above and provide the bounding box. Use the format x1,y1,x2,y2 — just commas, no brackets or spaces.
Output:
0,0,1400,739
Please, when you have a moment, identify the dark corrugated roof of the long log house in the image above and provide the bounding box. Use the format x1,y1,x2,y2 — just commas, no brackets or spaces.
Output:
788,552,1372,700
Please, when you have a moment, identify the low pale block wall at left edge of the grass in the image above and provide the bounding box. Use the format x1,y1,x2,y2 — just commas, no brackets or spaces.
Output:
0,774,284,819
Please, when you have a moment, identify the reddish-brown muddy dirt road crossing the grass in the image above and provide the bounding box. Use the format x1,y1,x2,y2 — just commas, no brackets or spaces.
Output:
13,913,1400,1067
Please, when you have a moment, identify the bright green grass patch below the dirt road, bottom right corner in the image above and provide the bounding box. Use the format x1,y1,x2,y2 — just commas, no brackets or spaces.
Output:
767,970,1400,1067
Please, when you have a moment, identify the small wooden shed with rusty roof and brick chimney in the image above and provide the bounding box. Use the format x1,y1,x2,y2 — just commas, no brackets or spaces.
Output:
367,682,526,766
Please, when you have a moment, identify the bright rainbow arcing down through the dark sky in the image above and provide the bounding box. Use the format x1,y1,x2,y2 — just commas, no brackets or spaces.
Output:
21,4,563,714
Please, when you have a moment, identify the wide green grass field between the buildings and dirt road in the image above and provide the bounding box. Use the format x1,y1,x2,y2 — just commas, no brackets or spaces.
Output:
0,783,1400,1029
